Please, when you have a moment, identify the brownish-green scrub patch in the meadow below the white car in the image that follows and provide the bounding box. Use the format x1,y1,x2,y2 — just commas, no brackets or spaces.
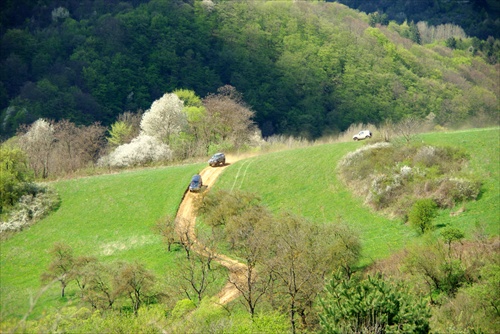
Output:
338,142,481,217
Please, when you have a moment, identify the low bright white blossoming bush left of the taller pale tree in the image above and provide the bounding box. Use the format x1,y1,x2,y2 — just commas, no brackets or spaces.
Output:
99,134,172,167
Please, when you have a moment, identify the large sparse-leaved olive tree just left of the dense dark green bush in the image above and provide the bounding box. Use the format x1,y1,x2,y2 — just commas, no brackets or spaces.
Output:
267,214,359,333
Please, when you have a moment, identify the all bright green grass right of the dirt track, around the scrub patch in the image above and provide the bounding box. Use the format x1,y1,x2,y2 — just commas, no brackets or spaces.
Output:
213,128,500,264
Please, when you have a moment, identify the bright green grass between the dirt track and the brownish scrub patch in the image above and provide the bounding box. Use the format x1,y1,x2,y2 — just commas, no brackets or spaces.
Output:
217,142,416,264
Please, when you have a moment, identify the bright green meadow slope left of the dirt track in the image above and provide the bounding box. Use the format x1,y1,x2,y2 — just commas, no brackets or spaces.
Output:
0,164,204,318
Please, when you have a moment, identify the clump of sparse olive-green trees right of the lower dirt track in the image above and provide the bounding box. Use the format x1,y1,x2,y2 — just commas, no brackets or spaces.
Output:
200,191,361,332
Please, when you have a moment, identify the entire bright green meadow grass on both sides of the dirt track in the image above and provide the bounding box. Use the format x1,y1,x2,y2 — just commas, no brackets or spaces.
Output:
0,128,500,319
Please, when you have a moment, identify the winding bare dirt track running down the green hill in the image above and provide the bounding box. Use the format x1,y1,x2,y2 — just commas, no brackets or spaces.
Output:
176,159,246,305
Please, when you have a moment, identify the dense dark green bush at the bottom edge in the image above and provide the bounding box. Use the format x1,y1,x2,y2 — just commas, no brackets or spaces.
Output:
320,273,431,333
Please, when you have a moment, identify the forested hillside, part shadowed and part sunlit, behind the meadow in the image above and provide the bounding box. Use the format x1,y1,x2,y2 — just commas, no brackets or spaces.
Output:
0,0,500,139
